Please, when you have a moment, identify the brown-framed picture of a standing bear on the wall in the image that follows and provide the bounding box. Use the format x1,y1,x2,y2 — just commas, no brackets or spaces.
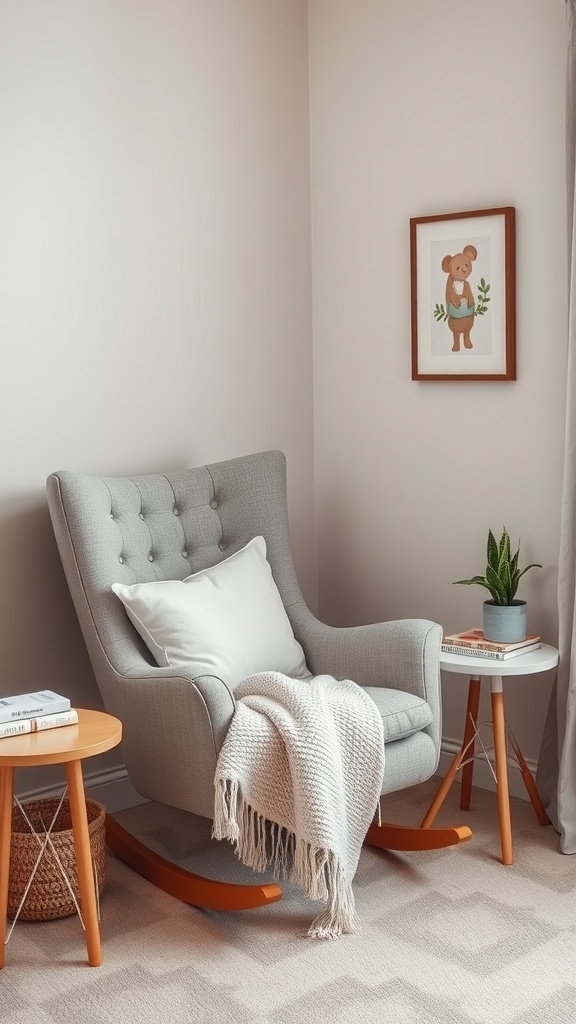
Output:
410,206,516,381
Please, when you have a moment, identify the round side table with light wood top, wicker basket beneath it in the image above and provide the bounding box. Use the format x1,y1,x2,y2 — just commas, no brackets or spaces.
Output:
0,709,122,968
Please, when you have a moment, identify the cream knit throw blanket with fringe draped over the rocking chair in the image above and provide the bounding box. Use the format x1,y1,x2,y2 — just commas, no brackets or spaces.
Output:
213,672,384,938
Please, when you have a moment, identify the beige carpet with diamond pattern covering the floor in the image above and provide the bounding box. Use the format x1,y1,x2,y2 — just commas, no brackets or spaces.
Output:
0,781,576,1024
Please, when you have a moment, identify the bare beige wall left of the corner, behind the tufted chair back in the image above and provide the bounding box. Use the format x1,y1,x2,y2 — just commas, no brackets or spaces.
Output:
0,0,316,788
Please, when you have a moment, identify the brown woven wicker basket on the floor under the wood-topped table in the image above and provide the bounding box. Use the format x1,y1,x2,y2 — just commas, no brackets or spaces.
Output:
8,799,106,921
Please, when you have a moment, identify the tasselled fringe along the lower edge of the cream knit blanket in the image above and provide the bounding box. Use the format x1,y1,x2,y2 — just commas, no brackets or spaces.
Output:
212,778,358,939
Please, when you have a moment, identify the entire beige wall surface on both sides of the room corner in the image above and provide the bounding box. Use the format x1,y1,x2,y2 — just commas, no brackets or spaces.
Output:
0,0,566,788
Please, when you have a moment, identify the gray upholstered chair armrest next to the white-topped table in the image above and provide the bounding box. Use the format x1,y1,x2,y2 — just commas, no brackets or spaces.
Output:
293,612,443,700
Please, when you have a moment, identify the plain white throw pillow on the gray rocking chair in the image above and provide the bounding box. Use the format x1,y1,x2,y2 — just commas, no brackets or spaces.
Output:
112,537,310,686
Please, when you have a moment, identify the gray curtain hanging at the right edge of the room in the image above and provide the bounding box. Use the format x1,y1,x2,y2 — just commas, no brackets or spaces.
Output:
536,0,576,853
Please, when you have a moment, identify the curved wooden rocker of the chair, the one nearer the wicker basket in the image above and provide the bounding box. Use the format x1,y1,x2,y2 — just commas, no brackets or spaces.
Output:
106,815,282,910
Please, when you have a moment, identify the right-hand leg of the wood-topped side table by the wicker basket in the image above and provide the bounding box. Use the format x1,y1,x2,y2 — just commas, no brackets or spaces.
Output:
66,761,102,967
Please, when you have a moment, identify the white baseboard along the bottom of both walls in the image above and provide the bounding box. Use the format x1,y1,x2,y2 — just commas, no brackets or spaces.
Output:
13,739,536,814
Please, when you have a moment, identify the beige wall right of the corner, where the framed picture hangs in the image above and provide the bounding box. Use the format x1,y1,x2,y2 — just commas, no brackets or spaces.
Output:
308,0,566,761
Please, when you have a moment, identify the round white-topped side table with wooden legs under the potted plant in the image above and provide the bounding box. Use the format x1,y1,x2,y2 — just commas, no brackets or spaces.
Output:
422,643,559,864
